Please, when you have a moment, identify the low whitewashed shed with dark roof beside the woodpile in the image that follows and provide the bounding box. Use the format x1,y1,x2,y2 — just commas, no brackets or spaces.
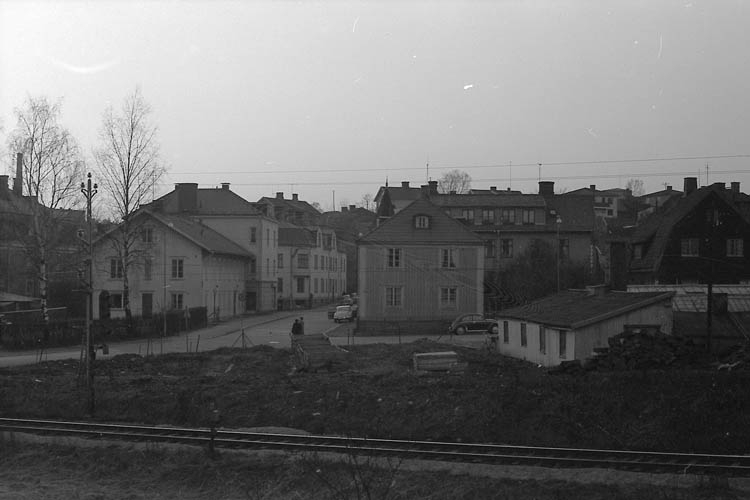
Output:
497,286,674,366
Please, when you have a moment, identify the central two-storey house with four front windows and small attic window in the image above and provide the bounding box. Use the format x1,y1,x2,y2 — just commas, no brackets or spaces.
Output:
357,198,484,334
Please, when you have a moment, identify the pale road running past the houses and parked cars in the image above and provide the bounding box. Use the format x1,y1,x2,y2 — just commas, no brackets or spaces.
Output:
0,308,484,367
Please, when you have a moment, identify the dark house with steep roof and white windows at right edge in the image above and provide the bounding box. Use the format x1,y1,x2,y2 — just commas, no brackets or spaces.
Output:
627,177,750,284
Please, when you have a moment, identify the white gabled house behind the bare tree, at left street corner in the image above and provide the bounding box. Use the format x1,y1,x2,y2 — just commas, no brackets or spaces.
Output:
93,208,252,319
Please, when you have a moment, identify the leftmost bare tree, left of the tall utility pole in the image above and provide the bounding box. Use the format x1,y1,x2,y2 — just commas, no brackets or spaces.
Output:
9,97,84,321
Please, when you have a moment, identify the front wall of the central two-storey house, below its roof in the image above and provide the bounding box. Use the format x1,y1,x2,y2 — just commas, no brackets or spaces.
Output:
358,245,484,333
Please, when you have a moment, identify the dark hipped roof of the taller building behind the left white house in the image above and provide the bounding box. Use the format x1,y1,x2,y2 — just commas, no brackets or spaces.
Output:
148,188,260,215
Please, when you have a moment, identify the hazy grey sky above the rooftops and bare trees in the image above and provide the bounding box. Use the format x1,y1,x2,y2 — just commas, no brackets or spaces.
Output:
0,0,750,210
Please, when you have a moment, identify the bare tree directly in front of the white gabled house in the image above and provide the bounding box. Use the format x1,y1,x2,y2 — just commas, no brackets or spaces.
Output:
94,88,165,322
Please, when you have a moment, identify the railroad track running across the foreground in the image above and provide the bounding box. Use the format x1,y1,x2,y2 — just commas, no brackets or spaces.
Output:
0,418,750,477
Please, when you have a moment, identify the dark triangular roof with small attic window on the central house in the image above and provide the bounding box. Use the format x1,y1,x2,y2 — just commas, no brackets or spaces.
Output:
359,196,484,245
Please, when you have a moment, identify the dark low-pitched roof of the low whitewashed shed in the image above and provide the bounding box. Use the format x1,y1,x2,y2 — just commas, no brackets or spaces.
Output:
498,290,674,329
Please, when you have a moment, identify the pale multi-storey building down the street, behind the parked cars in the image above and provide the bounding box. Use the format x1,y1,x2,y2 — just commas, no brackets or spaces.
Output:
276,222,348,309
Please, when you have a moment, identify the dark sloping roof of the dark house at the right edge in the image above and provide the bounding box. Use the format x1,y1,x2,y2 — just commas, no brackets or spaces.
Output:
630,184,747,272
